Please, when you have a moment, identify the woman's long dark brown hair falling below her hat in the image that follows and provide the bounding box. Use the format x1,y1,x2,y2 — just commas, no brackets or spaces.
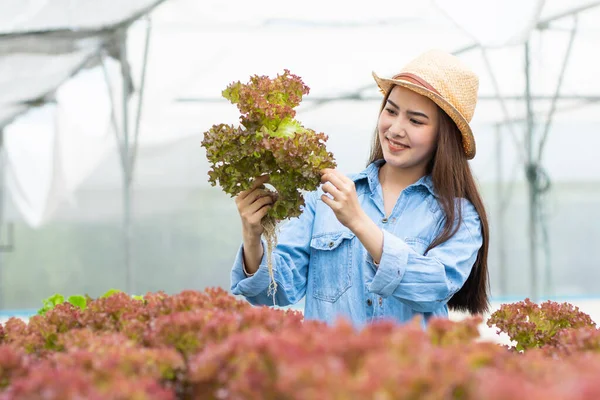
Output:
367,89,489,314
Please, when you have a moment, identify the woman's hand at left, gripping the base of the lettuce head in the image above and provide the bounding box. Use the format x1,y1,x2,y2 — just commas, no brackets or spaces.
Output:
235,175,273,239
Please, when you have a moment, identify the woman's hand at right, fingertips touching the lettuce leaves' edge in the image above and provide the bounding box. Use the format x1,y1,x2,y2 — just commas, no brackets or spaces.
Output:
321,168,364,230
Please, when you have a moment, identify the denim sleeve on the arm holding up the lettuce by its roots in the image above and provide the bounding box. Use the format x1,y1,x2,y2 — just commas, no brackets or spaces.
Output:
231,192,316,306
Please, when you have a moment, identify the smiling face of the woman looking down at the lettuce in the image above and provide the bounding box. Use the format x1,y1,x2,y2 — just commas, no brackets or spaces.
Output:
377,86,439,174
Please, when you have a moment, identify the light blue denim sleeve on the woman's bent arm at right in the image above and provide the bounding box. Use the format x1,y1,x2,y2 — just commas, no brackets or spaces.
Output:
367,199,483,312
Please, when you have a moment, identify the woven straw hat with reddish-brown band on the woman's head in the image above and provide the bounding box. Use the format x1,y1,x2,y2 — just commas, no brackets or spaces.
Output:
373,50,479,160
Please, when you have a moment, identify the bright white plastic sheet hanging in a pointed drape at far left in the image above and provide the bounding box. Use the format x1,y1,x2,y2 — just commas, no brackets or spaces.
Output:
4,60,122,227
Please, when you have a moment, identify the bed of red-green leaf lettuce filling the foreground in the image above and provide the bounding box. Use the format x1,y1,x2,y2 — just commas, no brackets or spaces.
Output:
0,288,600,400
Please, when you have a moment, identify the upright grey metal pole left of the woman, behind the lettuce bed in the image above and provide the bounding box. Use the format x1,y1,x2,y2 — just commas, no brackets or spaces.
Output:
120,30,135,294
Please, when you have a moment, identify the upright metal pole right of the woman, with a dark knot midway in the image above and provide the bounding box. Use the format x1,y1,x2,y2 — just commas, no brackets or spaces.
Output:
525,41,539,302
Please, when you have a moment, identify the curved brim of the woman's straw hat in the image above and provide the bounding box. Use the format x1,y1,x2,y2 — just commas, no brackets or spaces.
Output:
373,72,476,160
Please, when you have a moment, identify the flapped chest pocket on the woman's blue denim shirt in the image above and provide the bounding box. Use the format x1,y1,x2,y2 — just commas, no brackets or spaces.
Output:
310,231,354,303
